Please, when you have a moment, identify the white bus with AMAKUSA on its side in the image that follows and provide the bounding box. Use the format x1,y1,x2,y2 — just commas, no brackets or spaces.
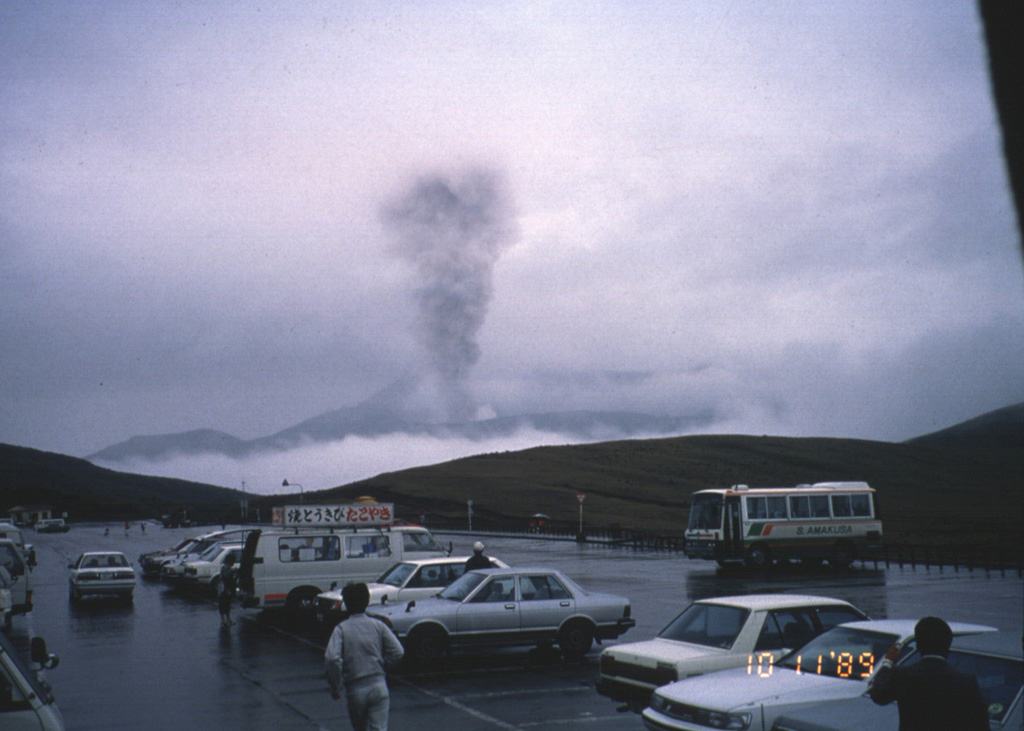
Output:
686,482,882,568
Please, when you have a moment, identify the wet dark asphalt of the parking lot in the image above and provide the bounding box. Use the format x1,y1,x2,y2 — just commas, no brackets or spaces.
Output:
11,523,1024,731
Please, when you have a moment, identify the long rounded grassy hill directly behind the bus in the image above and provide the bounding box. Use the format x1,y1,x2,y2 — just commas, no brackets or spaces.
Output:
315,436,1024,546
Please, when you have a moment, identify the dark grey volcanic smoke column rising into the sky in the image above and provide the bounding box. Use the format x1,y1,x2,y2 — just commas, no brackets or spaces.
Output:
383,170,516,422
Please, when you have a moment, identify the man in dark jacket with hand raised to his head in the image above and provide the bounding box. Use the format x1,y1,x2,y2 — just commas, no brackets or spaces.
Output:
868,616,988,731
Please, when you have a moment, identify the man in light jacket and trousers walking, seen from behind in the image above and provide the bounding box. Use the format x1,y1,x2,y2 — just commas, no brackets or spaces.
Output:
324,584,404,731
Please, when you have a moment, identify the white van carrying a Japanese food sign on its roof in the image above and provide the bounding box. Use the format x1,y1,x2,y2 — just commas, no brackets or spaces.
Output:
239,525,445,613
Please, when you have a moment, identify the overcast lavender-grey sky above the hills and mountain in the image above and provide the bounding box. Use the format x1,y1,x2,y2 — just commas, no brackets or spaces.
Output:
0,0,1024,487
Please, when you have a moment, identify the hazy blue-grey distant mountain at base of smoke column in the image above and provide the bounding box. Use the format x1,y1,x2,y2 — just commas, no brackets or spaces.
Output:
85,381,714,464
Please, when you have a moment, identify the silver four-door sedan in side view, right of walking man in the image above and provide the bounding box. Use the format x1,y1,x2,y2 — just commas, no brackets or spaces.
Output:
368,567,636,662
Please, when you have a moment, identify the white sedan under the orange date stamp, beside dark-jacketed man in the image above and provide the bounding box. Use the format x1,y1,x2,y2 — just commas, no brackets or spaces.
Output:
643,619,995,731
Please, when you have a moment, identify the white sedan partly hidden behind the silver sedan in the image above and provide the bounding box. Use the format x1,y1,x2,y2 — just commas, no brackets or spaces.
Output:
316,556,508,625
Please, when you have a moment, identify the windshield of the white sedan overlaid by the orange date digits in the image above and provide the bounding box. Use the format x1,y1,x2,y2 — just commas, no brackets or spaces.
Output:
778,627,899,680
